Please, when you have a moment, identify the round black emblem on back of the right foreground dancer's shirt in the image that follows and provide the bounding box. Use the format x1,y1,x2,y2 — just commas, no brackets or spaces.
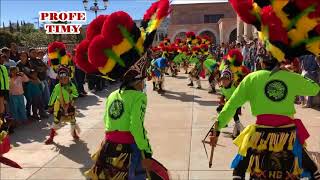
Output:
264,80,288,102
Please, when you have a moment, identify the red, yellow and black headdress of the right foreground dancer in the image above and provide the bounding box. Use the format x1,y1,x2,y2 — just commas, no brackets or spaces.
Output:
230,0,320,61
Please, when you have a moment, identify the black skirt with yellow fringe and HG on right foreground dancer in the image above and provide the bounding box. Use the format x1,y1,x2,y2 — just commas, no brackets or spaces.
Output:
231,125,303,179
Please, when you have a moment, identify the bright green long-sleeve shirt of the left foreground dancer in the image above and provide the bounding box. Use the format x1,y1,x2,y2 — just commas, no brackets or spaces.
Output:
104,90,152,154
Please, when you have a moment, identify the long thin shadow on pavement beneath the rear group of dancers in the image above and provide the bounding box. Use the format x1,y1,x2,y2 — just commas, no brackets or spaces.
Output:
161,90,219,106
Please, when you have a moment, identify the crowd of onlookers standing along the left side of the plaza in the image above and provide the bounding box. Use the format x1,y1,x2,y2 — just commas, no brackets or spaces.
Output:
0,43,104,132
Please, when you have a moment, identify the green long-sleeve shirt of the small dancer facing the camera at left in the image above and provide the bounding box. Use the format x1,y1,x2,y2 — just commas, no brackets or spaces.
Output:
48,82,79,106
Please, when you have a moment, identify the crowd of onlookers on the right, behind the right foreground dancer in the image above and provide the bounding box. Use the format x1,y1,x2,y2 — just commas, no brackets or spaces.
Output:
212,39,320,108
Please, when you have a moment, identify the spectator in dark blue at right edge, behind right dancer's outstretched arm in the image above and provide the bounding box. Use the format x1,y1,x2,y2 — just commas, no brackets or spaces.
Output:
300,55,320,108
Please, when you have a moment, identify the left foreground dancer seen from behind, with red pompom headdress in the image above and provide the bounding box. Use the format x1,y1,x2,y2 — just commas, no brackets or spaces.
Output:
76,0,170,180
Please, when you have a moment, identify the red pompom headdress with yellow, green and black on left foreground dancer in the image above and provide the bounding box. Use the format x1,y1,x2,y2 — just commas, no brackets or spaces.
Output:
76,0,170,79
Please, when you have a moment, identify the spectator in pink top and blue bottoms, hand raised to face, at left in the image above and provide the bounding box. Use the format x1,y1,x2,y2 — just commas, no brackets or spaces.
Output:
9,67,29,124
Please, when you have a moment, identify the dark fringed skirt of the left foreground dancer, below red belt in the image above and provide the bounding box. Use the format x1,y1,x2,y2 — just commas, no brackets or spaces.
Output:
86,141,145,180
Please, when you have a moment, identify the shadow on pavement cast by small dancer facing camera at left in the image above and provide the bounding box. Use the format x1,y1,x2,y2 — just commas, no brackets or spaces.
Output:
54,140,92,174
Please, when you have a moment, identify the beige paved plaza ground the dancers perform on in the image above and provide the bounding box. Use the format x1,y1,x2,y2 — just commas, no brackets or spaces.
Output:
0,74,320,180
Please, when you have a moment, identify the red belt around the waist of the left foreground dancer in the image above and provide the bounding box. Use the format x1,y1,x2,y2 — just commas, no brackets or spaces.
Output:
105,131,135,144
